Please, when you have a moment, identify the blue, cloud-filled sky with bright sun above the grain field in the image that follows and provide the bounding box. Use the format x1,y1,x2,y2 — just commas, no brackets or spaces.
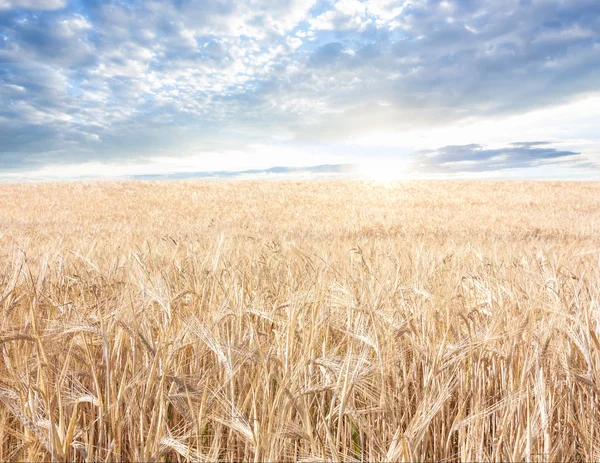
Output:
0,0,600,181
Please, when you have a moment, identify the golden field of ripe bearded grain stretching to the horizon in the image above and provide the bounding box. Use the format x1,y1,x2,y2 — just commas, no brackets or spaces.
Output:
0,181,600,462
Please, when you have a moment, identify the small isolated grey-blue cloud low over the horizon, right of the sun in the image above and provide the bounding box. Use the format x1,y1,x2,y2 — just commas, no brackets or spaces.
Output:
412,141,597,173
